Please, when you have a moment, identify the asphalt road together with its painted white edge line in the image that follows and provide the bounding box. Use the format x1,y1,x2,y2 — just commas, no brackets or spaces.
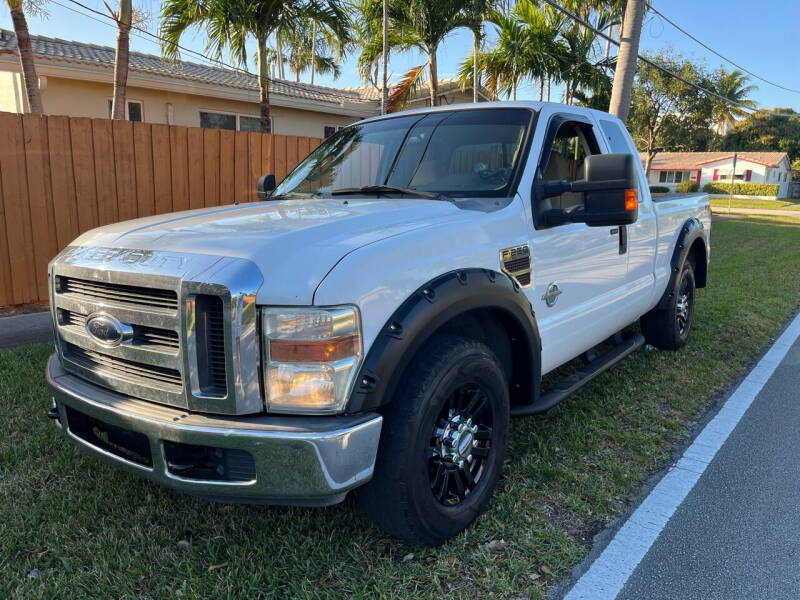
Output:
565,316,800,600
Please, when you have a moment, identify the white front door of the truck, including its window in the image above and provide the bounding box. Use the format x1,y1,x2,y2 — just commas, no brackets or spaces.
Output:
528,114,630,373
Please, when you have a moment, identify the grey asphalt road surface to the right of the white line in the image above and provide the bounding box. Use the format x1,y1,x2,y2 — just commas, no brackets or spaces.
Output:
617,340,800,600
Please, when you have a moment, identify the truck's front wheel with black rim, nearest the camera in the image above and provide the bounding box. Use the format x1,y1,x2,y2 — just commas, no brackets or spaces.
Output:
358,334,509,546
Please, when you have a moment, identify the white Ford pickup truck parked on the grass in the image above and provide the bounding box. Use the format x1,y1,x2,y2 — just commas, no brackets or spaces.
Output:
46,102,711,544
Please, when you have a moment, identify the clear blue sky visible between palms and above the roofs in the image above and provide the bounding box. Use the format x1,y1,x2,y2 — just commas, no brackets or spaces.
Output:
0,0,800,112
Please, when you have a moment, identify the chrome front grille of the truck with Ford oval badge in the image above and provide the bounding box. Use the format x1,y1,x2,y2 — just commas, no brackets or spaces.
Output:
50,247,263,414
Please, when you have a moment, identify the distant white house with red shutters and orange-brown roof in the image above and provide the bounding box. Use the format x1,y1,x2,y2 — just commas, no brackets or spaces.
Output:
640,152,792,198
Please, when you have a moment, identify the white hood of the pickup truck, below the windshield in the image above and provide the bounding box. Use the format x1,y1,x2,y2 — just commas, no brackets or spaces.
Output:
74,199,464,304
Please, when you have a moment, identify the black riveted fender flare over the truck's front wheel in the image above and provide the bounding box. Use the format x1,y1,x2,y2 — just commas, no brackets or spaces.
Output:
345,269,541,413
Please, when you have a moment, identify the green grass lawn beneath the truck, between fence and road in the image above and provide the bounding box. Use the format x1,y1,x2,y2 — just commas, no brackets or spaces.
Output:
0,218,800,599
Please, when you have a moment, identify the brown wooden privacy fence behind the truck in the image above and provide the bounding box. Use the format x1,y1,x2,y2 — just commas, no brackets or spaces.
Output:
0,112,322,306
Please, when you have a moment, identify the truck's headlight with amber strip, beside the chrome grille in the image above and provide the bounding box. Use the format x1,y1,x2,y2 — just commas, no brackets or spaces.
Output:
261,306,362,414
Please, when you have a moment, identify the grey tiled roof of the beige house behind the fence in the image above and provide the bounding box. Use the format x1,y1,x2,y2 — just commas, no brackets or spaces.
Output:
0,29,374,104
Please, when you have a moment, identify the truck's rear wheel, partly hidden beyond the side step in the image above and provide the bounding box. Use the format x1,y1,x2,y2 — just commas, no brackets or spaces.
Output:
641,259,695,350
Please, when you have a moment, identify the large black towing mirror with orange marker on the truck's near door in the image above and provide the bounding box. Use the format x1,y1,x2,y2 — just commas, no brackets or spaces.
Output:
538,154,639,227
